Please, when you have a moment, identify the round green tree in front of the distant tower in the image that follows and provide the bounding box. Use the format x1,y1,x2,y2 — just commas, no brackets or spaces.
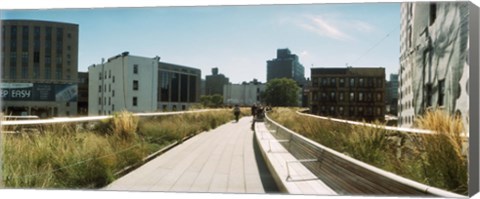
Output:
262,78,300,106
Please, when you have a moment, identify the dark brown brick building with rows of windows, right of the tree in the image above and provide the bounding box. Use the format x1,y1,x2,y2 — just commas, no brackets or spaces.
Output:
309,67,385,121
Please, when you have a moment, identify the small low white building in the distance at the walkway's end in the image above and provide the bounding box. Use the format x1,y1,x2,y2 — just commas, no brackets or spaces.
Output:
223,83,266,106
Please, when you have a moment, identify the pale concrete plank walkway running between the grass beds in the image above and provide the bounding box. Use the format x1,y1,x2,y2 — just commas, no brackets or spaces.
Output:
104,117,278,193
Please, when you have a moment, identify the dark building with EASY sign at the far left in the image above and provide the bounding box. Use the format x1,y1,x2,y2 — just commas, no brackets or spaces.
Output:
1,20,78,117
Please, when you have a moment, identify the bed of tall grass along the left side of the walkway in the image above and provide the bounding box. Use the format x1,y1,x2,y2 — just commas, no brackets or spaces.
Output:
1,109,239,189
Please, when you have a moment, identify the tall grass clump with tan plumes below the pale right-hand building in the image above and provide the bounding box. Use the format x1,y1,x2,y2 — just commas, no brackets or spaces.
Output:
416,110,468,193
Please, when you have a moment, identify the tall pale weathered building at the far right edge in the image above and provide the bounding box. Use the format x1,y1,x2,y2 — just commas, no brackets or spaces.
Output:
398,2,469,127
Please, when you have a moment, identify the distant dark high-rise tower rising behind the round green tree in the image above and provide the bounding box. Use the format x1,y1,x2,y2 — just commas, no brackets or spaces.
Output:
267,48,305,87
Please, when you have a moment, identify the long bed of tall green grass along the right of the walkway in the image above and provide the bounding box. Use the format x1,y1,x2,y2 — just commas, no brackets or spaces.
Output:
269,108,468,194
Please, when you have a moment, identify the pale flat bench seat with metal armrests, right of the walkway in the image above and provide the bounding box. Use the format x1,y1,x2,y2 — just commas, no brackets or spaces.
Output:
255,122,337,195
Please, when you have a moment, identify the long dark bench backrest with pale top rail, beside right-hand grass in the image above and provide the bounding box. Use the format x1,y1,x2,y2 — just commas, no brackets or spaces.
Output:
265,112,467,198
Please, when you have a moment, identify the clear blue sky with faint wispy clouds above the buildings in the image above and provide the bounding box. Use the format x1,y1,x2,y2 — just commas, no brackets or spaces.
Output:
0,2,400,83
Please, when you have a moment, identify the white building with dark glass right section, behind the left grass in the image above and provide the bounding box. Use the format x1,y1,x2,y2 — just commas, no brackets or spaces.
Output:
88,52,200,115
